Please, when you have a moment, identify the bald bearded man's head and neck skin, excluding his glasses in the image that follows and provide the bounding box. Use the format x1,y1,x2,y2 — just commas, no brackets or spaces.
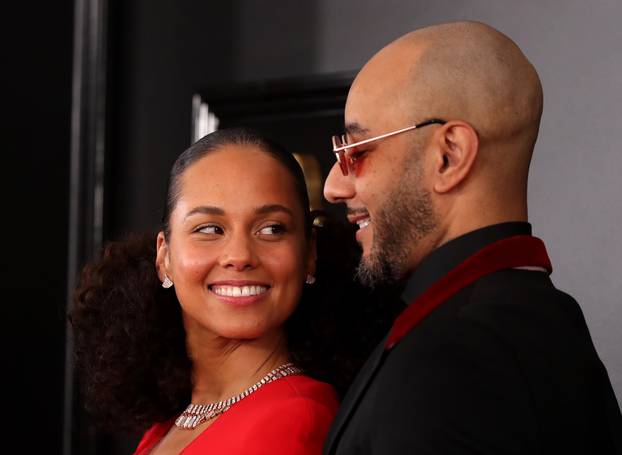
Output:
324,22,542,285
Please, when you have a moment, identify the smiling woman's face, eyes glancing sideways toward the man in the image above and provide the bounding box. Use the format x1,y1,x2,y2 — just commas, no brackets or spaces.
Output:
158,145,315,339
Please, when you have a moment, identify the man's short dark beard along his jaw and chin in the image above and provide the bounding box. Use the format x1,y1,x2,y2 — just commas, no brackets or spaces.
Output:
356,156,437,288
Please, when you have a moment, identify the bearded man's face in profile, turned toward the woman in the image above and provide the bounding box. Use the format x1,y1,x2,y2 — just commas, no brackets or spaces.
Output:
324,76,437,286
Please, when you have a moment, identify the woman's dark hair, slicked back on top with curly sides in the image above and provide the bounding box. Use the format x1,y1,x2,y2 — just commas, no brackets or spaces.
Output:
69,129,401,432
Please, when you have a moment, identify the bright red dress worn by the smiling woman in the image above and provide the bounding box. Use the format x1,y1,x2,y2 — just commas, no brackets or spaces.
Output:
134,375,338,455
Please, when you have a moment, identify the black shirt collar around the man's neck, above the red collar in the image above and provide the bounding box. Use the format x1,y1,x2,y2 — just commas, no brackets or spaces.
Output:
402,221,531,303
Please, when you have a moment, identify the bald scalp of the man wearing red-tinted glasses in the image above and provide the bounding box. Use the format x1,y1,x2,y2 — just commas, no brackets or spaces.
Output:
346,22,542,178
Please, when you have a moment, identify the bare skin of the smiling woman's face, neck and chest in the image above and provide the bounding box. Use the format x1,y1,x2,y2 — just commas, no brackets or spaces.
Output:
155,145,315,453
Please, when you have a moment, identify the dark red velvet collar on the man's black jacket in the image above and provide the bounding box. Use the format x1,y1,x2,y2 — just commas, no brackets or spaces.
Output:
385,235,553,349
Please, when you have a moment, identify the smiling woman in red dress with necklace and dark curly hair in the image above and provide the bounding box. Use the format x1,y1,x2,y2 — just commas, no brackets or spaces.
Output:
71,129,402,455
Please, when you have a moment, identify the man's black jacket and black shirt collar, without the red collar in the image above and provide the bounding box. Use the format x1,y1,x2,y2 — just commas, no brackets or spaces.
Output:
325,223,622,455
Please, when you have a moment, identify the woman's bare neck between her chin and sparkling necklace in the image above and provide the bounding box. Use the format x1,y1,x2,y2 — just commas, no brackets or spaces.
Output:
186,330,289,403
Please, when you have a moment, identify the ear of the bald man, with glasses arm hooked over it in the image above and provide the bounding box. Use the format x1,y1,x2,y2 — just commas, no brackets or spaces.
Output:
433,120,479,193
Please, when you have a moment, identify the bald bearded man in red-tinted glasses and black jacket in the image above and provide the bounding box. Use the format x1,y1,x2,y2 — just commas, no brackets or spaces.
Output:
324,22,622,455
